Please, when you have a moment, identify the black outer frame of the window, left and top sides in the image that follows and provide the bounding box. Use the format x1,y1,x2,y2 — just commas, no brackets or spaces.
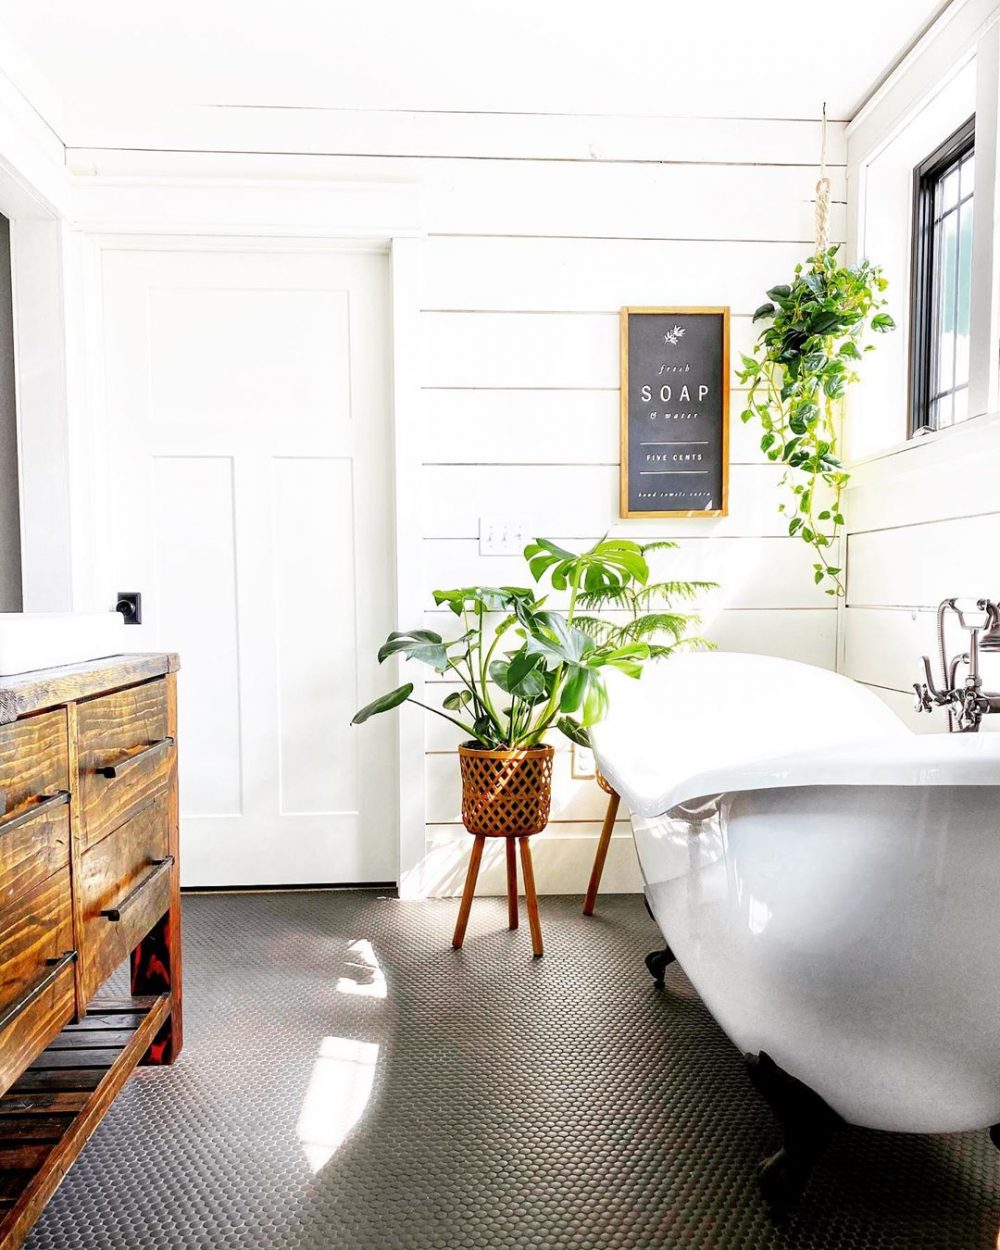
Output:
910,114,976,436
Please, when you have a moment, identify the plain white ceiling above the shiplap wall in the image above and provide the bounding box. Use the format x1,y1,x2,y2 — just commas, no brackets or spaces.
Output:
0,0,943,144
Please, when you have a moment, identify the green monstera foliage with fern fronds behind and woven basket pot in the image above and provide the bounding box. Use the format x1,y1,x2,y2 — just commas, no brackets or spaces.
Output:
354,538,713,829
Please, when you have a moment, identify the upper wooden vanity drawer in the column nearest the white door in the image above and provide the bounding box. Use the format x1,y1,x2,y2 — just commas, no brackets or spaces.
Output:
76,680,175,849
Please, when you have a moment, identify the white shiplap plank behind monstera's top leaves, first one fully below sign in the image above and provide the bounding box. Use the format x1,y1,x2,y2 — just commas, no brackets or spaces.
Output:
424,538,833,610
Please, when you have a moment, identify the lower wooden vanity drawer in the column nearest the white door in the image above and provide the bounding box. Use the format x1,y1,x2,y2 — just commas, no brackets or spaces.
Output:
79,794,173,1003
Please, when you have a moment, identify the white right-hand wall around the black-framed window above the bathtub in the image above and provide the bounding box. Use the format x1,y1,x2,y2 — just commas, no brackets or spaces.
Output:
841,0,1000,731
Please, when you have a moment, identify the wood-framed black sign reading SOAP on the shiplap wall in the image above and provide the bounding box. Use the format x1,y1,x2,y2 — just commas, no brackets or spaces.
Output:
621,308,729,516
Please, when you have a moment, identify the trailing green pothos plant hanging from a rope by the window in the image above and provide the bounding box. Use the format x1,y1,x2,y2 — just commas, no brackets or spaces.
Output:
738,244,895,595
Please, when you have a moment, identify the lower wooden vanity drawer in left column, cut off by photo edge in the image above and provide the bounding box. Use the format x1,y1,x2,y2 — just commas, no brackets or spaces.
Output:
0,868,75,1090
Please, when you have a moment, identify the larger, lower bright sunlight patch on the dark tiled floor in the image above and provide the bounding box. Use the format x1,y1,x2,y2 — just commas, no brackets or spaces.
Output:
296,1038,379,1175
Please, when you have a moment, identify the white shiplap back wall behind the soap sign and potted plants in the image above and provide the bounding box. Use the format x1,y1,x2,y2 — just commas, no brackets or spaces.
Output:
68,115,846,893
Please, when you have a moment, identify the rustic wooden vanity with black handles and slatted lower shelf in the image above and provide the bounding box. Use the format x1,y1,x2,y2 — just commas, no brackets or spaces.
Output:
0,655,183,1250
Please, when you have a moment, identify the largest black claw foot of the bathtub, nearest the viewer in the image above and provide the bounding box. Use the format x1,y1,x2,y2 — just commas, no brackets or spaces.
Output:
746,1051,843,1210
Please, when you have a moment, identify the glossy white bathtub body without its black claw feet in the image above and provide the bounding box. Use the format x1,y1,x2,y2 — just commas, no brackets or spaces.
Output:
593,653,1000,1133
